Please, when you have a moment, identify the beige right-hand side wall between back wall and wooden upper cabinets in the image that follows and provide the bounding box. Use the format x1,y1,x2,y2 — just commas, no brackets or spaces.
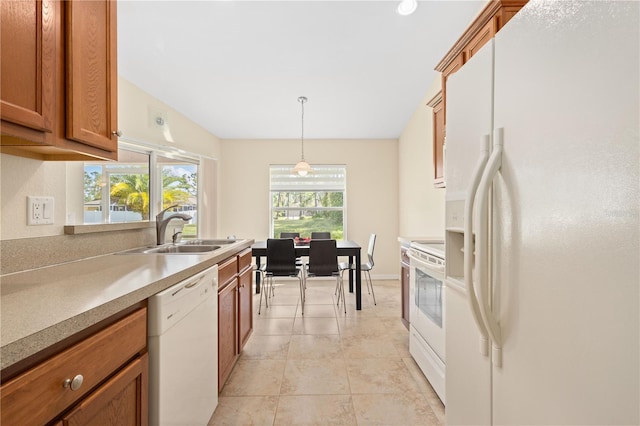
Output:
398,75,445,239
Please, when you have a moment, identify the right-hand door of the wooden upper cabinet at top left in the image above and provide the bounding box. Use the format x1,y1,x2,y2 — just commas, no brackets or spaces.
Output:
65,0,118,151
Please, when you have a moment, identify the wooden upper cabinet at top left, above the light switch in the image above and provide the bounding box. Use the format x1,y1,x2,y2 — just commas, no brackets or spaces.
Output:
0,0,118,160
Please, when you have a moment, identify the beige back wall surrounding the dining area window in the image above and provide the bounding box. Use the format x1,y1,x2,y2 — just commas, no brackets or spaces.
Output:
219,139,399,278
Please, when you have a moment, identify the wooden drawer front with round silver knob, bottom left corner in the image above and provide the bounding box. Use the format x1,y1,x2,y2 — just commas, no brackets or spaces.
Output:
0,308,147,425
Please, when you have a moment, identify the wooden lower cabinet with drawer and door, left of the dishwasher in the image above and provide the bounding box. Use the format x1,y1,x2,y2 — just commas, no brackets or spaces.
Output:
0,306,149,426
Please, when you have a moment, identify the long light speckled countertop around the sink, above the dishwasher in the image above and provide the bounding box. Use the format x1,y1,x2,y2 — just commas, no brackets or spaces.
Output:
0,239,254,369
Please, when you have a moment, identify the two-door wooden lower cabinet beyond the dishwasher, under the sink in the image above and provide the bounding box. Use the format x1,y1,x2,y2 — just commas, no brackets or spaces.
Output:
218,248,253,391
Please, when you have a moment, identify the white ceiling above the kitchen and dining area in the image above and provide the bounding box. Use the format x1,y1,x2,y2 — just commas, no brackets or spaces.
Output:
118,0,485,139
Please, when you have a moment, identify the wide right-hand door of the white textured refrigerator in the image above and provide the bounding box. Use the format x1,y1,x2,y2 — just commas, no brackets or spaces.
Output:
492,0,640,425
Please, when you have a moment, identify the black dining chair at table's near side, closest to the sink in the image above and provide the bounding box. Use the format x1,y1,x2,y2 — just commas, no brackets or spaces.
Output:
258,238,304,315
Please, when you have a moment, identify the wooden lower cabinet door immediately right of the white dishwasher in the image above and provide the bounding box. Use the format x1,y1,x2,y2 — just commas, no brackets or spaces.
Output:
218,278,239,391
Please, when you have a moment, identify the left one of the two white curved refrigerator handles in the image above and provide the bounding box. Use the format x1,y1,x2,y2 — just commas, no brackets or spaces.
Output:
463,135,489,356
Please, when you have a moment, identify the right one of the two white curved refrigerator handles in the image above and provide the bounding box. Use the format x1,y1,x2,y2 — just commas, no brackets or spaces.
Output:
476,128,504,367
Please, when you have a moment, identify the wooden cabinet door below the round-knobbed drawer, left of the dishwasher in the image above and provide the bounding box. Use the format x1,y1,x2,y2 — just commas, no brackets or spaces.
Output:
62,354,149,426
